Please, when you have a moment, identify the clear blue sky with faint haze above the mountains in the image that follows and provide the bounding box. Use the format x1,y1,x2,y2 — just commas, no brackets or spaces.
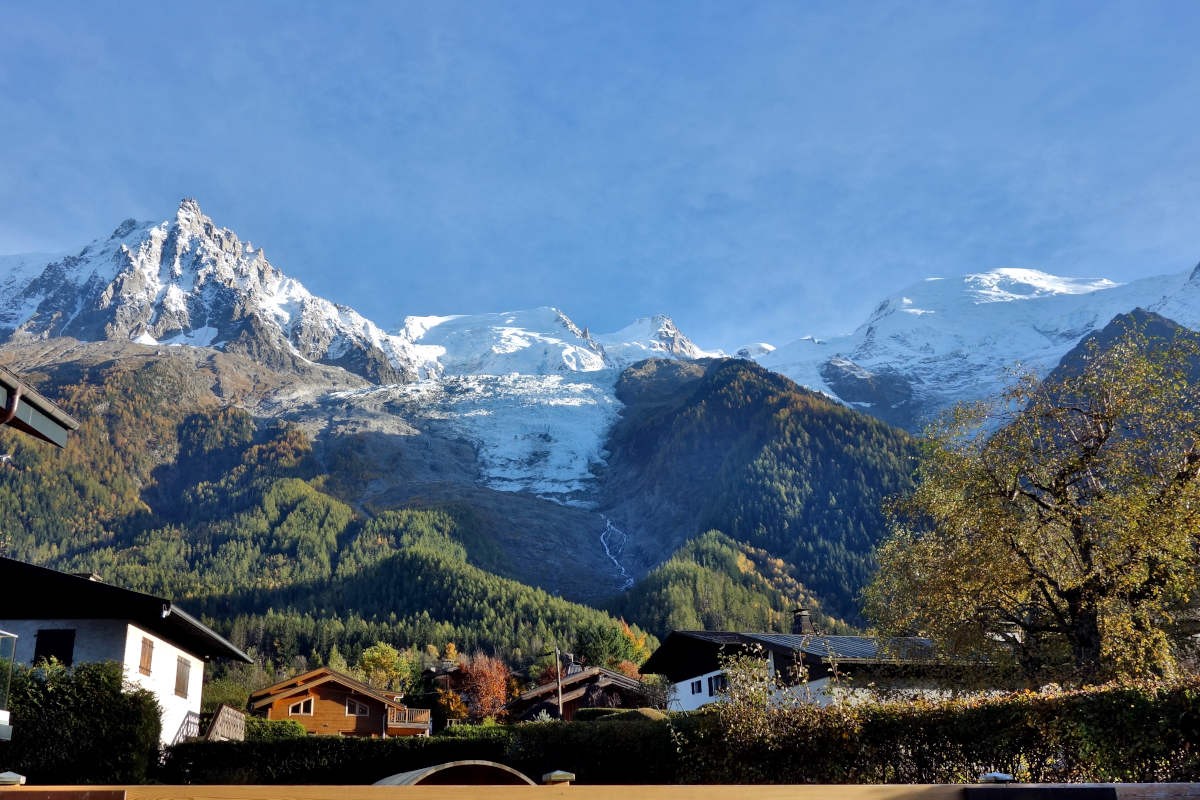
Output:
0,0,1200,348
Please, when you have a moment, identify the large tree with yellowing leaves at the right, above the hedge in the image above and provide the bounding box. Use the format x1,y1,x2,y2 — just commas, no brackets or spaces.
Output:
865,325,1200,682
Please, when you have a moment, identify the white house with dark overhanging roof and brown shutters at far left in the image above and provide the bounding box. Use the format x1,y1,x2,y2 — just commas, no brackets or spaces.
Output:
0,558,251,744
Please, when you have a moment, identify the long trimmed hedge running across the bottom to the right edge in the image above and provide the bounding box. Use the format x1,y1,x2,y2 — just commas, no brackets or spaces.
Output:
160,680,1200,784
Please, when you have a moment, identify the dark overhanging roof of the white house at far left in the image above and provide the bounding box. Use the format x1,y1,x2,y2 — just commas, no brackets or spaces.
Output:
0,557,252,663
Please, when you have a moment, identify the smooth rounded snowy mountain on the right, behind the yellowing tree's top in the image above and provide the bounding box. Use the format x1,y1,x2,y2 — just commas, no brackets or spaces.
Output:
758,269,1200,428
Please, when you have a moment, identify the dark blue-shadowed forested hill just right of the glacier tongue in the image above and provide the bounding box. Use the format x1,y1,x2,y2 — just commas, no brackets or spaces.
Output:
606,360,917,619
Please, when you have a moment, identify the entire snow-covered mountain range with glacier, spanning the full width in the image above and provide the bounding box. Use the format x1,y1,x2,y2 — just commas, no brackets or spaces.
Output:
0,200,1200,465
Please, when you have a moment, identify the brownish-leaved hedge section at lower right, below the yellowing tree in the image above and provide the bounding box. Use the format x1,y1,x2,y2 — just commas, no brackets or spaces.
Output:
676,680,1200,783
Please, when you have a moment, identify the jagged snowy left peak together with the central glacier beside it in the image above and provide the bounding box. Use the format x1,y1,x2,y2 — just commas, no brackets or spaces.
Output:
0,199,719,500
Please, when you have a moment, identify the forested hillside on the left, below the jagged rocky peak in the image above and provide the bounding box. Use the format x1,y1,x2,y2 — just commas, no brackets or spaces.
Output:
0,352,644,664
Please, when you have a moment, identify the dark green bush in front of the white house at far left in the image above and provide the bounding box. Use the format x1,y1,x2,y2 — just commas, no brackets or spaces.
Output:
0,662,162,784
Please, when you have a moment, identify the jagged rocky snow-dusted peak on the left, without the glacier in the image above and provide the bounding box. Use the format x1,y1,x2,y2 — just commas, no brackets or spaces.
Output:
0,199,421,381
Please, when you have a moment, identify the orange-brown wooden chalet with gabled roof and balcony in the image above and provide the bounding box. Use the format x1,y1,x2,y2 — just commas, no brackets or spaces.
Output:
250,667,432,736
